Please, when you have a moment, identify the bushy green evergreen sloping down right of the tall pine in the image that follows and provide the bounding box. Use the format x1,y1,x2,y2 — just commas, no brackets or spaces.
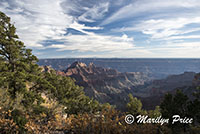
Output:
45,70,102,114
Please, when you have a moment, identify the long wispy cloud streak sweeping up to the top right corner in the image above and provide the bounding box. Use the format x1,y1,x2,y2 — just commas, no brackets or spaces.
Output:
102,0,200,25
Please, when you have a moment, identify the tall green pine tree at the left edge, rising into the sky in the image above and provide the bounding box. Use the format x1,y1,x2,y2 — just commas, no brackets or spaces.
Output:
0,12,50,110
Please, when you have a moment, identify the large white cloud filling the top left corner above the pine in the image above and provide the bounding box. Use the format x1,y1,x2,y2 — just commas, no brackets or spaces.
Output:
1,0,73,48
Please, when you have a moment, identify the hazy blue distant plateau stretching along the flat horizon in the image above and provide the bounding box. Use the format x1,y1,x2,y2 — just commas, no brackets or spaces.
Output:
38,58,200,79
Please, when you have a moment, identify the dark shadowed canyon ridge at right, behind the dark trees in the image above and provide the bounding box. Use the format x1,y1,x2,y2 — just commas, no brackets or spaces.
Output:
132,72,197,109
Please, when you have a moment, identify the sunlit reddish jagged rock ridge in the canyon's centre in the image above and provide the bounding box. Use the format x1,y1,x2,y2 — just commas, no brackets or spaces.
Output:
58,62,150,108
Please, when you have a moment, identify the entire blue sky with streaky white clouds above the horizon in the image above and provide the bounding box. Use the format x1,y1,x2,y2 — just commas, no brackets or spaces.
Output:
0,0,200,58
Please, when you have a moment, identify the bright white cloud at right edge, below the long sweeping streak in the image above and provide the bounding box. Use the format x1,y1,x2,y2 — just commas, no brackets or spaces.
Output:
136,17,200,39
